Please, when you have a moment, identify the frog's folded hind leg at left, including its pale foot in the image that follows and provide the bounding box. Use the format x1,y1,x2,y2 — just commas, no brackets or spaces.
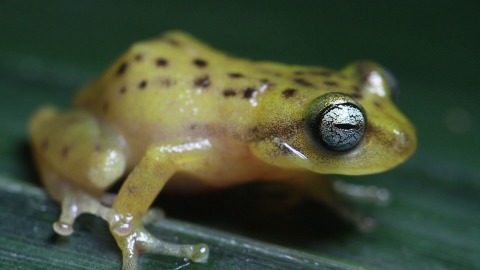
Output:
29,107,126,235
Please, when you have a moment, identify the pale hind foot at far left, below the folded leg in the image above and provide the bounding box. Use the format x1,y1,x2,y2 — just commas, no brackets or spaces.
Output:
53,190,119,236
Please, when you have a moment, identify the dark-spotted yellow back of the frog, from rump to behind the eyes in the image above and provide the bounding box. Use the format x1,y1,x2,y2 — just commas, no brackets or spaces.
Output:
76,32,358,156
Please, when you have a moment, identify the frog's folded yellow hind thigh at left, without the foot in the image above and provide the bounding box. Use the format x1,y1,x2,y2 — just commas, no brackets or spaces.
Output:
29,107,126,194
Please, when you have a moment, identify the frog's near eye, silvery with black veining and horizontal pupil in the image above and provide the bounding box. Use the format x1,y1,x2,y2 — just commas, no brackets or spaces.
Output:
308,93,366,152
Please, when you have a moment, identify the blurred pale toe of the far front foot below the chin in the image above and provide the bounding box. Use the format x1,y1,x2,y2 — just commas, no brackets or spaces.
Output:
333,180,390,205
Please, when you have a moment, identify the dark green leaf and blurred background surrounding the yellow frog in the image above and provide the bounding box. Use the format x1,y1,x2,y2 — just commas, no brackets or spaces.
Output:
0,1,480,269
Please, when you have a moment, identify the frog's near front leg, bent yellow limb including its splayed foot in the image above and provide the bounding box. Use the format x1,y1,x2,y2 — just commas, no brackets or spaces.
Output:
110,140,211,269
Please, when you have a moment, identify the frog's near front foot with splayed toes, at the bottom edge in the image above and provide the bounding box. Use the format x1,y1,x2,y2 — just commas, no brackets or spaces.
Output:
110,221,209,270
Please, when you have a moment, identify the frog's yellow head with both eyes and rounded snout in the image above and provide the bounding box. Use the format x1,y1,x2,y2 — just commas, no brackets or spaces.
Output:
253,62,416,175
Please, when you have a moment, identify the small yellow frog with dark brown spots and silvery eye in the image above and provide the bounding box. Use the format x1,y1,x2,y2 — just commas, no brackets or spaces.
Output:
28,30,416,270
